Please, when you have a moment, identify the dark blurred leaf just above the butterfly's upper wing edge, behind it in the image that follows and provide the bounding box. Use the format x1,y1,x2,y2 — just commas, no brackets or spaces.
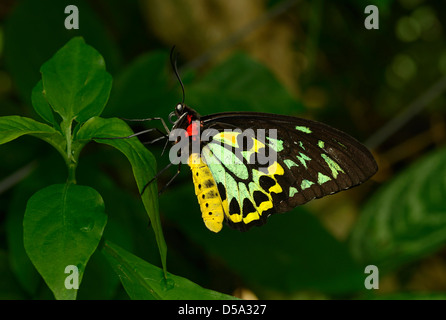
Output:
186,53,303,115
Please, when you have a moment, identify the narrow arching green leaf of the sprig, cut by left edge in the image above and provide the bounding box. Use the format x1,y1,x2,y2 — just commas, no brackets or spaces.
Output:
0,116,66,155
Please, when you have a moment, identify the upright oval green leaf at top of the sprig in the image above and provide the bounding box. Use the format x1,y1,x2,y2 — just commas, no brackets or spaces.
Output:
40,37,112,123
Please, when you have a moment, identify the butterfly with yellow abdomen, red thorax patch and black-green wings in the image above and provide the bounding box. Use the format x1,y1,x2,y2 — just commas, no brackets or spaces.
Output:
128,48,378,232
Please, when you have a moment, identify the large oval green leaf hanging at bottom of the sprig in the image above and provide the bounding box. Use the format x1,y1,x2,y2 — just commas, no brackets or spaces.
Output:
23,184,107,299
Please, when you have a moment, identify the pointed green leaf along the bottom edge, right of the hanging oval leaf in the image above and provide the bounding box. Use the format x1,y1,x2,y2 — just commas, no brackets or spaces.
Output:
102,241,235,300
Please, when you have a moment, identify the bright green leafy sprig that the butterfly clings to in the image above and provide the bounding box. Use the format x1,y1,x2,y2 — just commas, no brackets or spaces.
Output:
0,37,166,299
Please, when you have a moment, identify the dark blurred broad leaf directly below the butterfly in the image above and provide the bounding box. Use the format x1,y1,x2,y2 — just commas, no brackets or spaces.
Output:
160,182,364,294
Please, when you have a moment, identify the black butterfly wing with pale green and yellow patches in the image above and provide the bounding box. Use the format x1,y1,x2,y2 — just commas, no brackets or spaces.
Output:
201,112,377,230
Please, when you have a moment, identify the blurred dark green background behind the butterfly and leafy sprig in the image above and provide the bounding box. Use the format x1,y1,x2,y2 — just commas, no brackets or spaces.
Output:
0,0,446,299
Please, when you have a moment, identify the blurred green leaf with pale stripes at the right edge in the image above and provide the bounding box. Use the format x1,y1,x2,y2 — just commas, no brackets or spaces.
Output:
350,148,446,269
